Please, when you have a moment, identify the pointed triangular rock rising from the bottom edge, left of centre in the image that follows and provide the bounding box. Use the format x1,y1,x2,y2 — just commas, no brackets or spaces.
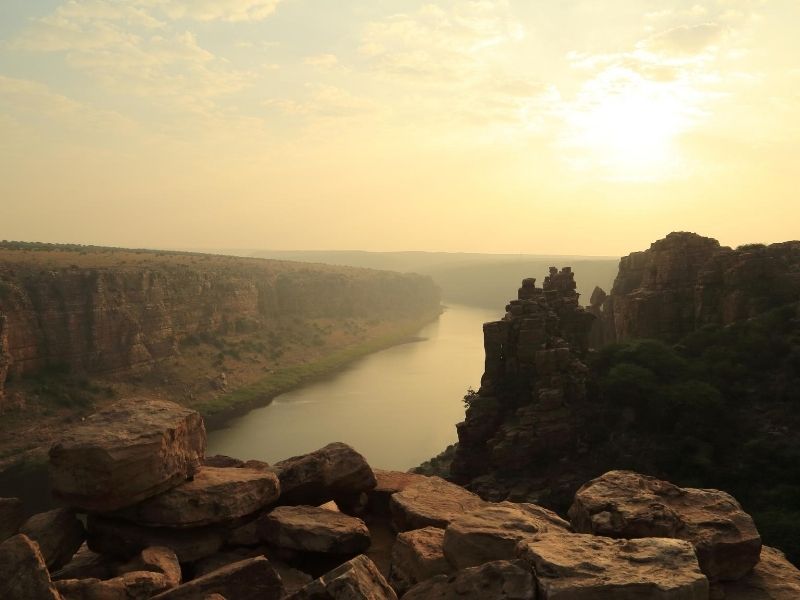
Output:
285,554,397,600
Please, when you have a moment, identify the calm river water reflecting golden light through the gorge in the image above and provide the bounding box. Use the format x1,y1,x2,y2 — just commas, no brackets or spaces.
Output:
207,305,498,470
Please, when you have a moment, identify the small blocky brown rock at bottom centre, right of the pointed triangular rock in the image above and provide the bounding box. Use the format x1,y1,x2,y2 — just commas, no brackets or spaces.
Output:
389,527,453,595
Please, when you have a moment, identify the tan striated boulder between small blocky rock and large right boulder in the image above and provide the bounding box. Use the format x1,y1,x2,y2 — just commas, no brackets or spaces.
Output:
444,502,570,569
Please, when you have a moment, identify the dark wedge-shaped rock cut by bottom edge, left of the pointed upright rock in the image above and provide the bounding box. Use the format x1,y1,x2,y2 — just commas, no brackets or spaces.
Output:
153,556,284,600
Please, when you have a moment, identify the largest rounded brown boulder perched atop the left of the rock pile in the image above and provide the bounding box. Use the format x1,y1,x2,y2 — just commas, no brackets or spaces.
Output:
50,398,206,511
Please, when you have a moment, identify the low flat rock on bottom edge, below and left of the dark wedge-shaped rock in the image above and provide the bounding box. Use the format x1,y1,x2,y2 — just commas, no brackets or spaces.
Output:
55,571,173,600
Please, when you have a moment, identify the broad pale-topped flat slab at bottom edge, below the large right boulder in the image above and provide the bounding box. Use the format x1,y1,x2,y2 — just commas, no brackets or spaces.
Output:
518,533,709,600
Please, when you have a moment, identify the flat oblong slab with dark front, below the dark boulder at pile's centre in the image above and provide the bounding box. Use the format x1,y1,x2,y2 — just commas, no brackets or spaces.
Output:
258,506,370,555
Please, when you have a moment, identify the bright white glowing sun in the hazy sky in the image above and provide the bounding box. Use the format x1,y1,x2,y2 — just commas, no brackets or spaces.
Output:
567,71,690,180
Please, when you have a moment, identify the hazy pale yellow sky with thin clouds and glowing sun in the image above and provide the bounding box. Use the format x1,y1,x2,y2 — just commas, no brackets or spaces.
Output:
0,0,800,255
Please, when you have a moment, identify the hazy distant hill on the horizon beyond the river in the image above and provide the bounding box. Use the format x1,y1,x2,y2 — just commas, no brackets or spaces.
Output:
253,250,619,308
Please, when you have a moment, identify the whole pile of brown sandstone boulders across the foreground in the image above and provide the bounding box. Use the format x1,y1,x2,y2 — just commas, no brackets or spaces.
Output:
0,399,800,600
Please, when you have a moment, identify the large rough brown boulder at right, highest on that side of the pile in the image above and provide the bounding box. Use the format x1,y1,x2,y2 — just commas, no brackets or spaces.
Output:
569,471,761,581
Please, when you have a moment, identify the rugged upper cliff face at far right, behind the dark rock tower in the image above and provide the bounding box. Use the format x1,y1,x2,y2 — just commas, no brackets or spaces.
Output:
591,232,800,347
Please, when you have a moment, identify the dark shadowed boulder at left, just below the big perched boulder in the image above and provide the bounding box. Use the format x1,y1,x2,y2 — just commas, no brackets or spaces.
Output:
19,508,86,571
